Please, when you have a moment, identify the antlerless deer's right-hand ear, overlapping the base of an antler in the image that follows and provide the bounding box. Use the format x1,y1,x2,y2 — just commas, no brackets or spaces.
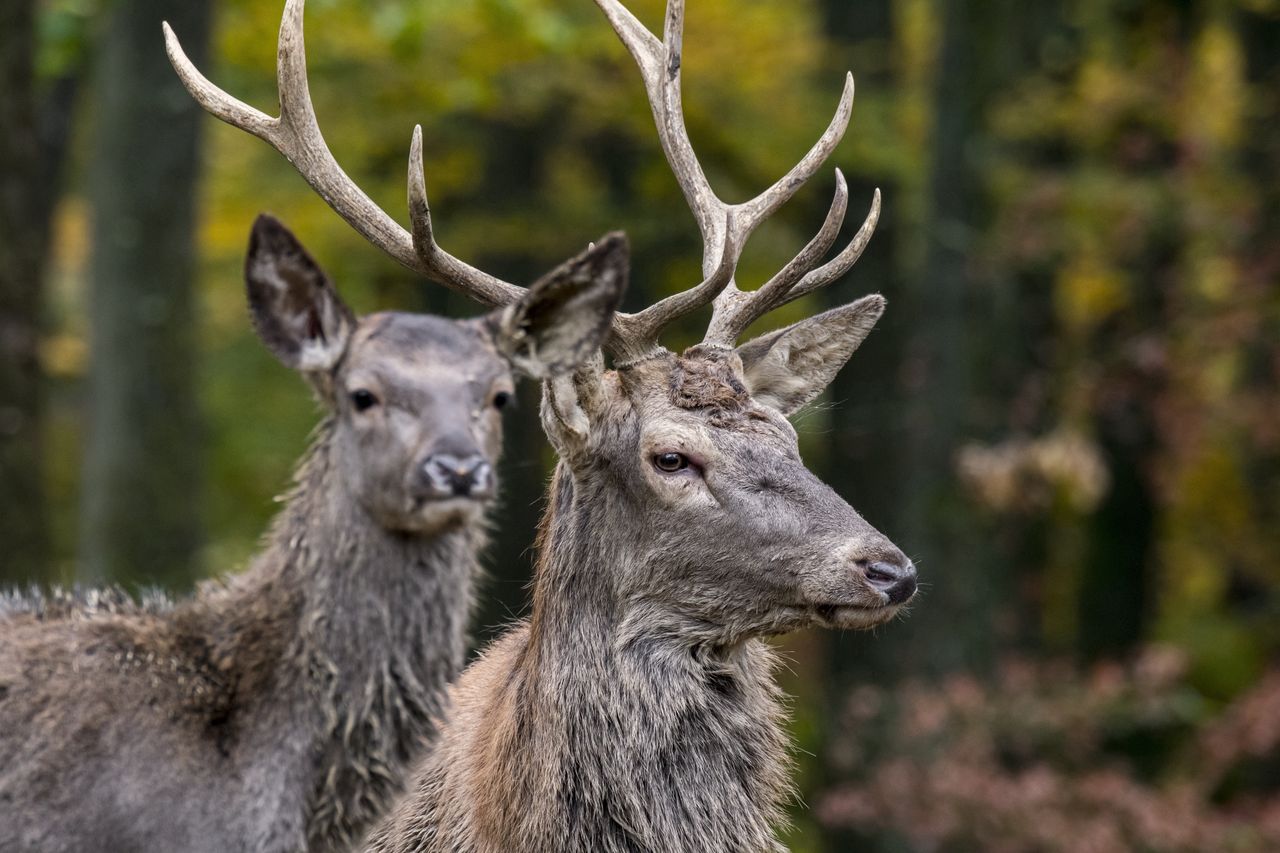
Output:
494,233,630,379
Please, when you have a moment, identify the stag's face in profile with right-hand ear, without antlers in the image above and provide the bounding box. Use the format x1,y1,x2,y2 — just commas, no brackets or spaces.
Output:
550,297,916,642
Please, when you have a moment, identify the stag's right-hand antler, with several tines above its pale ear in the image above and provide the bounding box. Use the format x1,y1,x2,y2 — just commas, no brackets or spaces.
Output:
595,0,879,357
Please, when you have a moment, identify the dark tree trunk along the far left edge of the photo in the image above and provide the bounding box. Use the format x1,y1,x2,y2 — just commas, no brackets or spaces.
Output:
0,0,49,585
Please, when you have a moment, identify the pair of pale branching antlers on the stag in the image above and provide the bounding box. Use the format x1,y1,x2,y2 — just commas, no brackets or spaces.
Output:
164,0,879,360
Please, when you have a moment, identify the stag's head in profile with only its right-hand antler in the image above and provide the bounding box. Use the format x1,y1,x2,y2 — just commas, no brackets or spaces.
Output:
524,0,916,644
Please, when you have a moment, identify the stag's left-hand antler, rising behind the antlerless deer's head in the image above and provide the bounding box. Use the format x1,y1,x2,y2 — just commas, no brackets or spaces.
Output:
164,0,525,307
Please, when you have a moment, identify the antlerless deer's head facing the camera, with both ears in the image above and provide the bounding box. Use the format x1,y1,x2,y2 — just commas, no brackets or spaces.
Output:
246,216,625,533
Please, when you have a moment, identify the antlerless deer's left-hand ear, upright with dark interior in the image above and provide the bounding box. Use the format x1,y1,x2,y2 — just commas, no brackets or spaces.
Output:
244,214,356,373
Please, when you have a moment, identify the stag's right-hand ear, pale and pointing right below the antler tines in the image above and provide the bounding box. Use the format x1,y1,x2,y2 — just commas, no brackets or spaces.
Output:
737,293,884,415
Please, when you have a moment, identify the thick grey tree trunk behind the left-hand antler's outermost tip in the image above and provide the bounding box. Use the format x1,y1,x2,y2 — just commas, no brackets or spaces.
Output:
81,0,210,588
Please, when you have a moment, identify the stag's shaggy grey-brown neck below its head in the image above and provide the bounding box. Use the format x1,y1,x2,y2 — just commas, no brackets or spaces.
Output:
515,465,788,850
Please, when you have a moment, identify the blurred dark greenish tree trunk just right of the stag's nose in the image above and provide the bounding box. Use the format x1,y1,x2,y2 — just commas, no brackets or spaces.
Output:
900,0,996,675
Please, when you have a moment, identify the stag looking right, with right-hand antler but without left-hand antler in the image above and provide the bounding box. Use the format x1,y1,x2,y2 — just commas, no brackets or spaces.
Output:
355,0,918,853
